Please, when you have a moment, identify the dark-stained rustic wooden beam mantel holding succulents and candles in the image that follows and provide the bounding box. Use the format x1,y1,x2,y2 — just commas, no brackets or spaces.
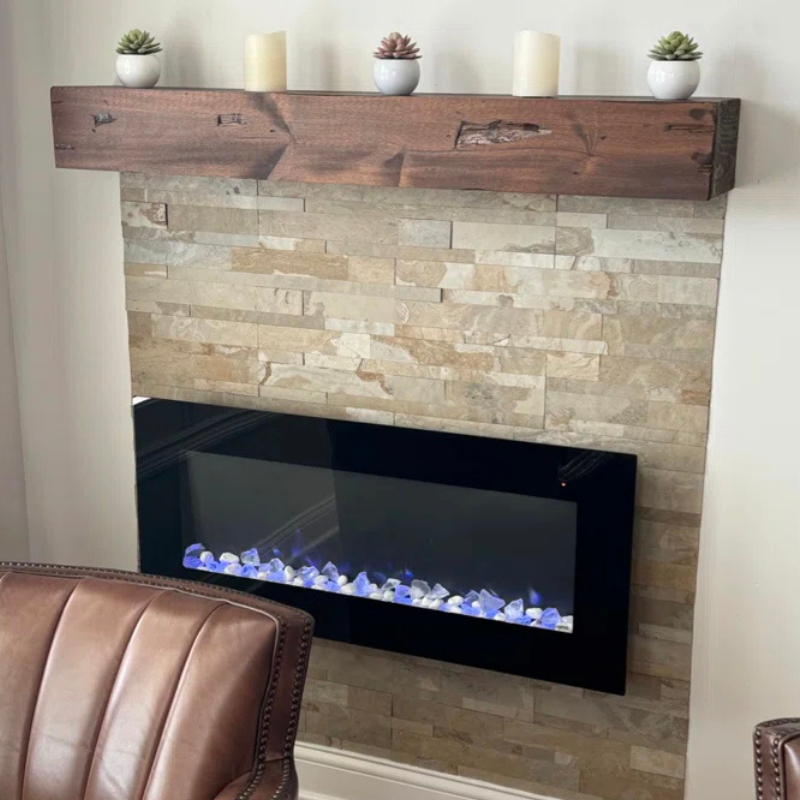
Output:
51,86,740,200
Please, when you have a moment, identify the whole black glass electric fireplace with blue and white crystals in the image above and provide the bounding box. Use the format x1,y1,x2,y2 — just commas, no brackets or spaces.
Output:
134,400,636,693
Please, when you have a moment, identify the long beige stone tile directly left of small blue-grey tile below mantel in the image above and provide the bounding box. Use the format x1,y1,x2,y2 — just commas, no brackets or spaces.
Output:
259,211,398,245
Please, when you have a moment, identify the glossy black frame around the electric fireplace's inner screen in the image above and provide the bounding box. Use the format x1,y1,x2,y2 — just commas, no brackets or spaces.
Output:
134,400,637,694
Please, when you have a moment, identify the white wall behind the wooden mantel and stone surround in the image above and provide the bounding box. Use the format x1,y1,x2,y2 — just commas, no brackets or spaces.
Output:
0,0,800,800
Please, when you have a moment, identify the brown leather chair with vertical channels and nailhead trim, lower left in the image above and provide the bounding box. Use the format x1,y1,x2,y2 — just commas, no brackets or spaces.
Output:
0,563,313,800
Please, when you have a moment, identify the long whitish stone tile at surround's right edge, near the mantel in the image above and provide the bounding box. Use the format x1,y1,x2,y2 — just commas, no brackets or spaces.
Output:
555,228,722,264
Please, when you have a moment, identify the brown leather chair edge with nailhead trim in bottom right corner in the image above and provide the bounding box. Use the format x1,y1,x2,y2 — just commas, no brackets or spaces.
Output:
753,718,800,800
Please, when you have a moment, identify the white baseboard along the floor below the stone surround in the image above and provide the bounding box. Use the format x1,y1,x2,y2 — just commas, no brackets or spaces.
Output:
295,744,553,800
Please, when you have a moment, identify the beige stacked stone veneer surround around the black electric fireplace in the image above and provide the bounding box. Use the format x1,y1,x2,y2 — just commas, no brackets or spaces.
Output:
122,174,725,800
